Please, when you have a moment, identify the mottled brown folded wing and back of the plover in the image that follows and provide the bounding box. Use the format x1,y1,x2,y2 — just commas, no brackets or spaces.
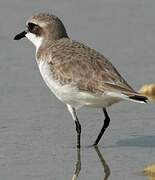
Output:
39,39,137,94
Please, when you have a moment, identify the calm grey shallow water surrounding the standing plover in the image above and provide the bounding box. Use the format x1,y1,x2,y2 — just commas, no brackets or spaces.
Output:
0,0,155,180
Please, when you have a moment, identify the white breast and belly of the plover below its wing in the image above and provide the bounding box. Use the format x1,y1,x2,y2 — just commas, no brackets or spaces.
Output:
38,62,120,108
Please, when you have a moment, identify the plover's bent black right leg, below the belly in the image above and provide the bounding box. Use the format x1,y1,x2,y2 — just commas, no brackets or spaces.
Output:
94,108,110,146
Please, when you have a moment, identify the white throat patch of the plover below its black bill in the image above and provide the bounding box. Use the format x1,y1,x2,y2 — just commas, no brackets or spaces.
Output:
26,32,43,52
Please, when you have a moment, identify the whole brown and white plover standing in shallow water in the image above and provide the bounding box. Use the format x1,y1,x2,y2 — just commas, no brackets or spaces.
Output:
14,13,147,148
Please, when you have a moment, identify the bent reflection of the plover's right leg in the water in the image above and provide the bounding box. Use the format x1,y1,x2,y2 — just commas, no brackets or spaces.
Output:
95,146,110,180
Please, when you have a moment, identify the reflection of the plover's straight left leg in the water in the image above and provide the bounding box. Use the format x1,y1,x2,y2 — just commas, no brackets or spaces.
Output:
72,148,81,180
